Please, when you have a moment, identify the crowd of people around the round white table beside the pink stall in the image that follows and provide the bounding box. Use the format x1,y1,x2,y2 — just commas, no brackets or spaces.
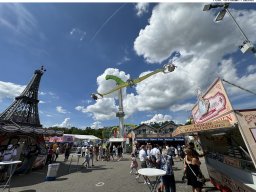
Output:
130,142,205,192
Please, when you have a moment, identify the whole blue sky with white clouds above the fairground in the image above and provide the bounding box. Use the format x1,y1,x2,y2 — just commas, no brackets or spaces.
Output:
0,2,256,129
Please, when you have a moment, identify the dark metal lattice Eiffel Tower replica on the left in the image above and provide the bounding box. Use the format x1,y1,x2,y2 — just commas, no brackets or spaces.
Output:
0,66,46,127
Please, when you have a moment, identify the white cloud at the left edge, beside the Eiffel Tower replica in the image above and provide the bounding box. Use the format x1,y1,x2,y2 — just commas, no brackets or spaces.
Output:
0,81,26,102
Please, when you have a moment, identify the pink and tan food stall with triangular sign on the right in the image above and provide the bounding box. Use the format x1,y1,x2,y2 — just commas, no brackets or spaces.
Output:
173,79,256,192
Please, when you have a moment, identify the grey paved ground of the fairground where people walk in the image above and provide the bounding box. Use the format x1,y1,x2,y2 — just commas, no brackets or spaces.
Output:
6,154,217,192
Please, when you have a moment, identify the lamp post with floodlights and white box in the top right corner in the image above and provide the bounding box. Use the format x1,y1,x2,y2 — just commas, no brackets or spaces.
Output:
203,3,256,55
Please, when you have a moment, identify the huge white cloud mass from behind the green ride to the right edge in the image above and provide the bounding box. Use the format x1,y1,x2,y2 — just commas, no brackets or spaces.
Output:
77,3,256,120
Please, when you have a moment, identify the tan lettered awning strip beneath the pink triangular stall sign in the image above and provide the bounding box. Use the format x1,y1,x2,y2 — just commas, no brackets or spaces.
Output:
172,120,232,137
